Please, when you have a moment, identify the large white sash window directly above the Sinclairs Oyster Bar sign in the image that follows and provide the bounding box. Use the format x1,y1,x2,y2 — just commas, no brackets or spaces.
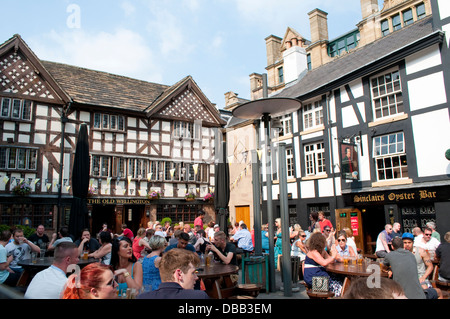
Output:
373,132,409,181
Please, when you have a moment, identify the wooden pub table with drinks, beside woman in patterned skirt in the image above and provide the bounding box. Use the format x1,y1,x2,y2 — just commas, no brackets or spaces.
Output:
326,260,388,295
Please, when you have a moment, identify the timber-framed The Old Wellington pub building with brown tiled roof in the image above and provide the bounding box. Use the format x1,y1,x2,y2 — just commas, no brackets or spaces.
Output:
0,35,225,236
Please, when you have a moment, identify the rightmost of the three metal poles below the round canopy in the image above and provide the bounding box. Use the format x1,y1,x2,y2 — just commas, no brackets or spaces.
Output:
278,143,292,297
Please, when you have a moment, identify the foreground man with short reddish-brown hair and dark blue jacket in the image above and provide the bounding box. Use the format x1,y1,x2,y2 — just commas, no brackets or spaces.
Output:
137,248,209,300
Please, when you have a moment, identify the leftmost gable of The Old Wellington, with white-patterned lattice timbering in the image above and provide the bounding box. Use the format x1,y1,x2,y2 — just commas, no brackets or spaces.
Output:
0,34,71,104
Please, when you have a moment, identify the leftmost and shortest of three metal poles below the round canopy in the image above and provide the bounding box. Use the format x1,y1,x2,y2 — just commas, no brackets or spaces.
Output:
252,150,262,256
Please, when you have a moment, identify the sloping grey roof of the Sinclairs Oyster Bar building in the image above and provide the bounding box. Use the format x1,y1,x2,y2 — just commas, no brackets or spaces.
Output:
275,18,443,99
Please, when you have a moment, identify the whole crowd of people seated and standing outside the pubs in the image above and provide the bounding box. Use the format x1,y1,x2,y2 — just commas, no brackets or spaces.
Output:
0,212,450,299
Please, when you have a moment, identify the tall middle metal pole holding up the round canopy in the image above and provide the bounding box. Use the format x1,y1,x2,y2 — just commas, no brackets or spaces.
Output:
262,113,276,292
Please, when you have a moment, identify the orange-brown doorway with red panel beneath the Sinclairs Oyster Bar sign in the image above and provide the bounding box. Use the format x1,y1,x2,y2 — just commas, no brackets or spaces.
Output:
335,208,365,254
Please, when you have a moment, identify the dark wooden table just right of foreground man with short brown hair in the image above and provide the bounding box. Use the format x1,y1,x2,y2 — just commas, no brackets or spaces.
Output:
197,261,239,299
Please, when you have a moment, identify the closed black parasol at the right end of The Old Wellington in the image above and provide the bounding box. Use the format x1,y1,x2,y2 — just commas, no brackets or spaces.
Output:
214,142,230,236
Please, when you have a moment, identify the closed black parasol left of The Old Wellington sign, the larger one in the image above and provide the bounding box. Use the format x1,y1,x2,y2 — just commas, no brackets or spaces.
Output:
69,123,90,237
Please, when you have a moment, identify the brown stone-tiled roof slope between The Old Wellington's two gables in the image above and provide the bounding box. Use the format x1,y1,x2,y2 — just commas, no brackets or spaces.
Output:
42,61,170,111
